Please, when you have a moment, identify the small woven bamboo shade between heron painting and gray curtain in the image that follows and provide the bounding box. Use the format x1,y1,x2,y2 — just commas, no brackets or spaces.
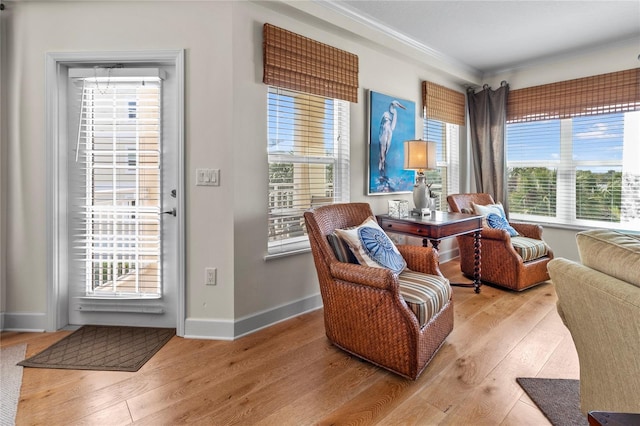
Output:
422,81,465,126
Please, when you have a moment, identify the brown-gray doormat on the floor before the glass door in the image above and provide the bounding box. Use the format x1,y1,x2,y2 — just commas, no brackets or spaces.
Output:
19,325,176,372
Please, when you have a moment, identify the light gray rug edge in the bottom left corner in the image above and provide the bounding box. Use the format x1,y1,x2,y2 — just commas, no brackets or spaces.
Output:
0,343,27,426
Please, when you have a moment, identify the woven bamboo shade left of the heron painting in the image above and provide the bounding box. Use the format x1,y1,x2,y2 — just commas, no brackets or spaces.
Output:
262,24,358,102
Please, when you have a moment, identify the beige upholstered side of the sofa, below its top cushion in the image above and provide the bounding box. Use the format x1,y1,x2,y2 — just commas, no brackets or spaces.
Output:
548,258,640,413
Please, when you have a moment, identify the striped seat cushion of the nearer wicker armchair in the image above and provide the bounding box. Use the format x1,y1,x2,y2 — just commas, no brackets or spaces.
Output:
398,269,451,328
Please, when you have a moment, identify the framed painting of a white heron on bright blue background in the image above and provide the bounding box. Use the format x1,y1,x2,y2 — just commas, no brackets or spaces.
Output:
368,90,416,195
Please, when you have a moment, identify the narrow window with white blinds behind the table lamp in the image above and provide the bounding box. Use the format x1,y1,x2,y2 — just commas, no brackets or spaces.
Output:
422,118,460,211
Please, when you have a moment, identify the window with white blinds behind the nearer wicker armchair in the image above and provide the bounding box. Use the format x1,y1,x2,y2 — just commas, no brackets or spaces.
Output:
267,87,349,255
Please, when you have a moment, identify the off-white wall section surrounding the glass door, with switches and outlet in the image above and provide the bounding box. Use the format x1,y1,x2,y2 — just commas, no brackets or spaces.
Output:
2,2,234,332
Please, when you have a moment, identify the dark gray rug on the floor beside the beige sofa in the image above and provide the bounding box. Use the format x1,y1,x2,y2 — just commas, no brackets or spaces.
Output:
516,377,589,426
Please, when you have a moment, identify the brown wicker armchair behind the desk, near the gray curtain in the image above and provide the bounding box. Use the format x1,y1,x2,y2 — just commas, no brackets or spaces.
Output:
447,193,553,291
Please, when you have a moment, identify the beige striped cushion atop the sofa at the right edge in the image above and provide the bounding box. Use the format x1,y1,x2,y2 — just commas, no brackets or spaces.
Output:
576,229,640,287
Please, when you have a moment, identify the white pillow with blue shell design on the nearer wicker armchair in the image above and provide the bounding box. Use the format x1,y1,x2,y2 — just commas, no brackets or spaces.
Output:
335,217,407,274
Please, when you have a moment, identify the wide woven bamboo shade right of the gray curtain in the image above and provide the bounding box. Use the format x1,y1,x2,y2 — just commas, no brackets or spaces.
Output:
507,68,640,123
